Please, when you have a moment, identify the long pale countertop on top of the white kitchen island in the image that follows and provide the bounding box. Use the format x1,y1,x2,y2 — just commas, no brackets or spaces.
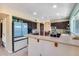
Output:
28,34,79,47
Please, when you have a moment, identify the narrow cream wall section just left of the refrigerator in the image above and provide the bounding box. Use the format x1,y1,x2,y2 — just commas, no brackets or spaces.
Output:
2,16,12,53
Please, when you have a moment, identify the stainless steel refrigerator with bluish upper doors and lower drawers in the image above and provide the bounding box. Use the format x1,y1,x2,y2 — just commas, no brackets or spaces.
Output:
13,22,28,52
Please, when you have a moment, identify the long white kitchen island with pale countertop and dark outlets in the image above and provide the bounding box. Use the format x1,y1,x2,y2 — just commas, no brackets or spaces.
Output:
28,34,79,56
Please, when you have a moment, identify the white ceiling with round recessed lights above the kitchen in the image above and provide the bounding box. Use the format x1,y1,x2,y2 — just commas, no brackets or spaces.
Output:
0,3,75,20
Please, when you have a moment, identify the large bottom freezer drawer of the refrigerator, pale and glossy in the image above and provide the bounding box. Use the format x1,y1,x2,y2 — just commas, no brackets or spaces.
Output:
14,39,27,51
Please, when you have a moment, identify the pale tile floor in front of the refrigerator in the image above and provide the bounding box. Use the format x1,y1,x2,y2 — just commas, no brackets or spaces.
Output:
0,47,28,56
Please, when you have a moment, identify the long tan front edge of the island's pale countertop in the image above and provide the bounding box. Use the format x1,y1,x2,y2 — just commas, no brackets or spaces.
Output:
28,34,79,47
